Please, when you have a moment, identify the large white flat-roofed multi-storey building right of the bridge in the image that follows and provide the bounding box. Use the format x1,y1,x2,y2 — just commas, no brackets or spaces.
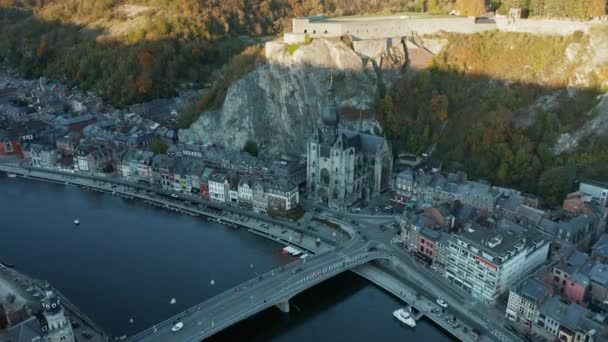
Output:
445,220,549,303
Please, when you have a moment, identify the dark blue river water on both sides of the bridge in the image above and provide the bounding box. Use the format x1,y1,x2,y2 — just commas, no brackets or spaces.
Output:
0,172,451,341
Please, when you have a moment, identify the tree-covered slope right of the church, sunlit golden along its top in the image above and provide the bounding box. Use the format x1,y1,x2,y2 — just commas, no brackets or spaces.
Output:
378,32,608,203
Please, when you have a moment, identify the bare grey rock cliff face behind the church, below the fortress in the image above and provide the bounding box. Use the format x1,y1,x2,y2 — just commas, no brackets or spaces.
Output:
179,39,406,154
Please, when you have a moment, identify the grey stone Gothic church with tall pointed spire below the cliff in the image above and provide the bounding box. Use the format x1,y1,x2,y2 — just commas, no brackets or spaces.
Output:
306,81,393,209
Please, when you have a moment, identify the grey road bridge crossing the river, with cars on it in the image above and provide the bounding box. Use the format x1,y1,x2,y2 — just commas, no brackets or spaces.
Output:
128,240,391,342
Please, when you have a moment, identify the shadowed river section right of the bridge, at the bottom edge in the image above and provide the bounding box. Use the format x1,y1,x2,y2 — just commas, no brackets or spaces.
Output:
208,272,454,341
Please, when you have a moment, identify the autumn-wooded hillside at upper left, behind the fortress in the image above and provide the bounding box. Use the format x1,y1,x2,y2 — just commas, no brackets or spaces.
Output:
0,0,451,106
